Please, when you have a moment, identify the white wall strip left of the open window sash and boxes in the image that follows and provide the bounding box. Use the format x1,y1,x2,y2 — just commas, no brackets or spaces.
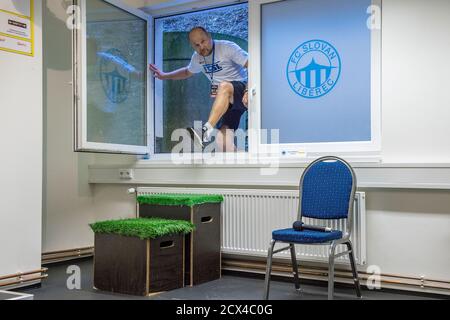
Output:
42,0,134,252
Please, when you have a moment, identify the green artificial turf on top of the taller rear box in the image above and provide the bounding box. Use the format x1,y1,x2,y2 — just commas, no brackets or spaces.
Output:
137,194,223,207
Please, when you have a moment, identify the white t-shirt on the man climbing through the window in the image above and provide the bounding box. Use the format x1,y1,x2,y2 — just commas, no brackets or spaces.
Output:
188,40,248,85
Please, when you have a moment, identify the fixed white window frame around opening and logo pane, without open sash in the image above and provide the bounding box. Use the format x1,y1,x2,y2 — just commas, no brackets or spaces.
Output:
143,0,382,162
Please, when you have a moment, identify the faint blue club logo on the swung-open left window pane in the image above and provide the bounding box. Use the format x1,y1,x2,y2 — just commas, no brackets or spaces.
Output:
97,49,131,104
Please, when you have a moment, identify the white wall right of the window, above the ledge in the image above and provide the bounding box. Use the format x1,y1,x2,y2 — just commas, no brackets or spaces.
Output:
382,0,450,163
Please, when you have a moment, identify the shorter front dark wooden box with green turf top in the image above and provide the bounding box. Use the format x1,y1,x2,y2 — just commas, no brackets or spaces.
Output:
90,218,194,296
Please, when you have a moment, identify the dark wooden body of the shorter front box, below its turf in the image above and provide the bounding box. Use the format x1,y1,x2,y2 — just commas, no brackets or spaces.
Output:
94,233,185,296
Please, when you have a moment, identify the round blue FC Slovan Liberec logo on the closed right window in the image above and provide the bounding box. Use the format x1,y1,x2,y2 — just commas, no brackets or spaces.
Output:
287,40,341,99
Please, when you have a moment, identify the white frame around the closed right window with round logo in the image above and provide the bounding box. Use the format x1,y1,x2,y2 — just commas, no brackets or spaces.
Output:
249,0,381,162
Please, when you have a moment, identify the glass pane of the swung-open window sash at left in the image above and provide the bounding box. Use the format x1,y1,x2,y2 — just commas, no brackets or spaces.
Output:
86,0,147,146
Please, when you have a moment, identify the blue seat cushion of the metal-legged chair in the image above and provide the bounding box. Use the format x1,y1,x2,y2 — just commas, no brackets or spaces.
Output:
272,228,342,243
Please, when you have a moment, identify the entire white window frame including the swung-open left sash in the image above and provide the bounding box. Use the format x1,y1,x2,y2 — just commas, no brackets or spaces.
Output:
72,0,382,162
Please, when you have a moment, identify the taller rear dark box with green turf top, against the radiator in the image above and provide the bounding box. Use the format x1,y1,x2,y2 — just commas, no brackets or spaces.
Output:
138,194,223,286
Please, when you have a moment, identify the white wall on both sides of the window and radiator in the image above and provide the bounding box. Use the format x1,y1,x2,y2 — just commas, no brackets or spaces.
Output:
43,0,450,290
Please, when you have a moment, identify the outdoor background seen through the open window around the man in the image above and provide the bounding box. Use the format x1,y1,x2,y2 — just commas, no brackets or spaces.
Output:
155,4,248,153
